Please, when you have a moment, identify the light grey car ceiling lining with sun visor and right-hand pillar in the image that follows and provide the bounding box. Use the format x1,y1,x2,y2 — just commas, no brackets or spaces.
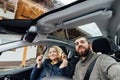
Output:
36,0,120,47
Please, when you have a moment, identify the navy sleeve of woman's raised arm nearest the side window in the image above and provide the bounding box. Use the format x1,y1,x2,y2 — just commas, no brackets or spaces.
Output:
30,64,42,80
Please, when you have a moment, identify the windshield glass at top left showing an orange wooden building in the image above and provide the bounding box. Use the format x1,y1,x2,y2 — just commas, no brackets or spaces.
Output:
0,0,76,19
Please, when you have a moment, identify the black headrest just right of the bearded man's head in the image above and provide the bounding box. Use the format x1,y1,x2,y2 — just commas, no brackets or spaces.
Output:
92,38,111,54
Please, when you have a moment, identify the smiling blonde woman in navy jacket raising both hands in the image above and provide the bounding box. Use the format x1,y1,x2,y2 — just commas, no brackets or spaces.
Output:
30,46,70,80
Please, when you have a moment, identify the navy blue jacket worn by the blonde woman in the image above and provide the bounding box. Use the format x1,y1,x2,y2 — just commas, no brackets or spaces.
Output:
30,59,70,80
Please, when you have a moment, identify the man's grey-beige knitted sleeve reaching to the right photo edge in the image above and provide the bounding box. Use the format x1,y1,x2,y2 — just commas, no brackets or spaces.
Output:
100,55,120,80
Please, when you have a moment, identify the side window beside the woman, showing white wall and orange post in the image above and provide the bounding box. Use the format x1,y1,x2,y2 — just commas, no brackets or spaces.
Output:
0,45,45,70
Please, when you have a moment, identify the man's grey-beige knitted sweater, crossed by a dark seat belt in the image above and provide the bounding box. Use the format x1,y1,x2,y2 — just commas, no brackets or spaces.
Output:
73,53,120,80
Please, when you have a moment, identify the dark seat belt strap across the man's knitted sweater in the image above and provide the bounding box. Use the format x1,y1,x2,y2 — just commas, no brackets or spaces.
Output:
83,56,98,80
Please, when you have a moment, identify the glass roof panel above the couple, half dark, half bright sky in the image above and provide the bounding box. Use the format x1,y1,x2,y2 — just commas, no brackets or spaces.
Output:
49,22,102,40
